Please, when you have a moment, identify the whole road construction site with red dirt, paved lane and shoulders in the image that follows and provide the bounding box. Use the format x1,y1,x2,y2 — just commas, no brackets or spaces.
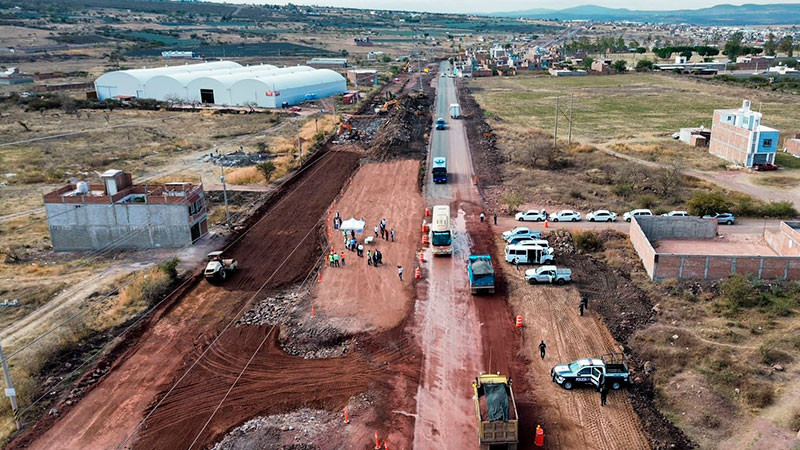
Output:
10,63,680,449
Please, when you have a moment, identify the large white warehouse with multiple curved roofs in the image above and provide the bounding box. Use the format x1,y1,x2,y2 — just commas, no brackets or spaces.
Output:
95,61,347,108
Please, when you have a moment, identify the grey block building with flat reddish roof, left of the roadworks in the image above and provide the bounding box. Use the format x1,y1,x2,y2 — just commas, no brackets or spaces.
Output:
44,169,208,251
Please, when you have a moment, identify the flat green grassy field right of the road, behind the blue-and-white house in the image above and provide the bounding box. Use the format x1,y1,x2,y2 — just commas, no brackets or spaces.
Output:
470,74,800,143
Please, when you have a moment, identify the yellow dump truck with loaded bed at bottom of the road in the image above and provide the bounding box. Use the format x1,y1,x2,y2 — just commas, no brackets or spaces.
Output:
472,372,519,450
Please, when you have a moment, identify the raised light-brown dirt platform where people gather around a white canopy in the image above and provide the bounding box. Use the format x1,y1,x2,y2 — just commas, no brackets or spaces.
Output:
314,160,424,333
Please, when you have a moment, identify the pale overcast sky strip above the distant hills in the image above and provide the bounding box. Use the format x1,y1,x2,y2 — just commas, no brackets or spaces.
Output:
211,0,800,13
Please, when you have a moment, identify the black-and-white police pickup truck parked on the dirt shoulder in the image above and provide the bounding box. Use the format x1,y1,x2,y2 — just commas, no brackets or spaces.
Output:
550,353,631,390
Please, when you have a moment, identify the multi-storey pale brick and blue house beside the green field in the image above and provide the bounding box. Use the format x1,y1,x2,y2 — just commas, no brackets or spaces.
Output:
708,100,779,167
